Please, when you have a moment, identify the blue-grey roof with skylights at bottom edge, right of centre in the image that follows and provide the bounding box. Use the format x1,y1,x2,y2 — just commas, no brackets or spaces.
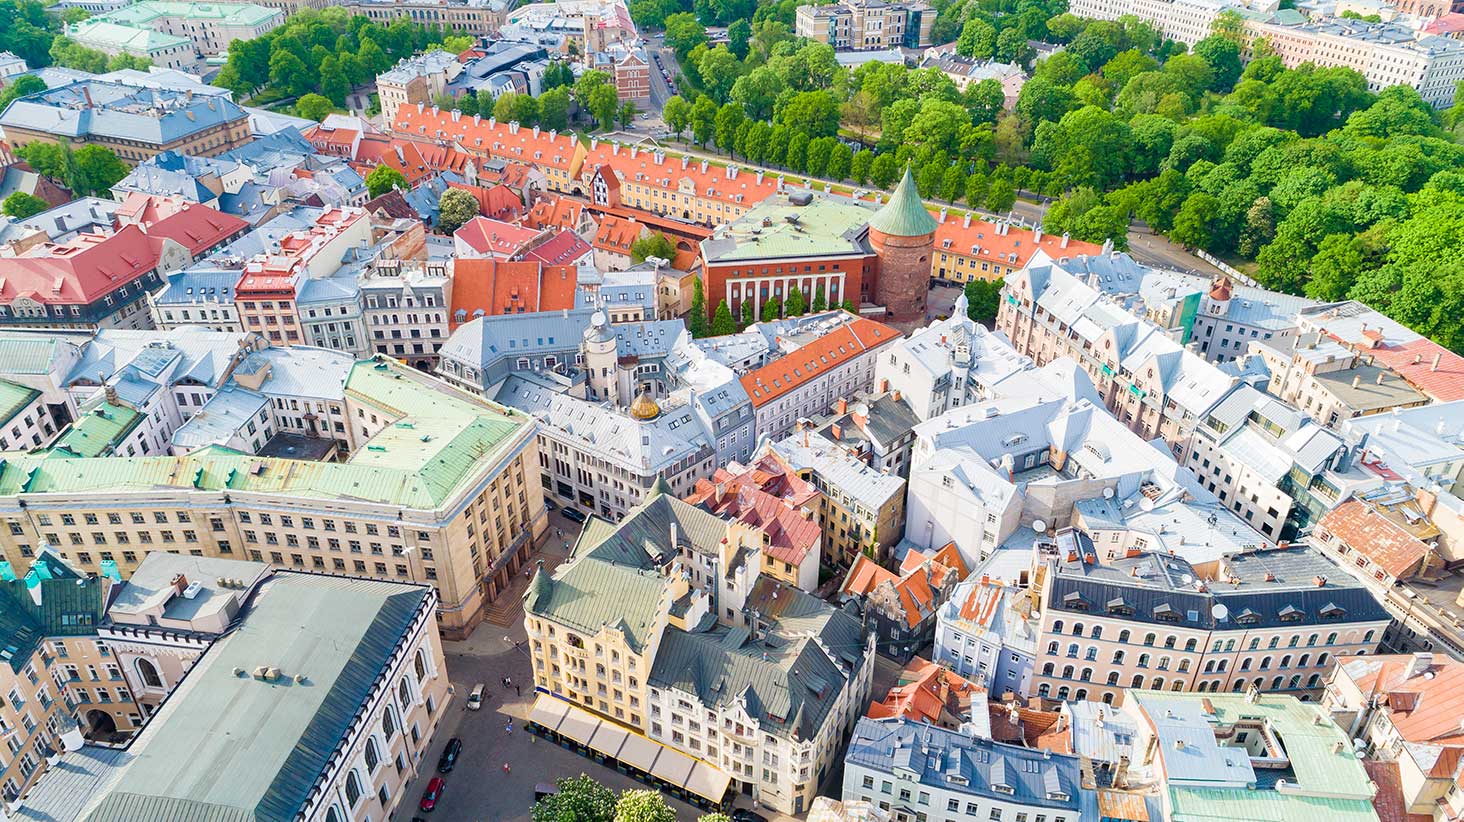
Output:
845,717,1082,819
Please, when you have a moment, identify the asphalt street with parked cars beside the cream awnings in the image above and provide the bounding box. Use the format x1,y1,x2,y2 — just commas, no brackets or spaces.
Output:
392,511,701,822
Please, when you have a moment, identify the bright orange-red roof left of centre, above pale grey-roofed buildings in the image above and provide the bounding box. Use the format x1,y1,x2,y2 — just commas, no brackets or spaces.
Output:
451,256,577,328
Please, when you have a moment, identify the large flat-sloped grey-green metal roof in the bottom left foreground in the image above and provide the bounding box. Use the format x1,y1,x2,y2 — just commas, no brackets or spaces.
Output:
85,571,429,822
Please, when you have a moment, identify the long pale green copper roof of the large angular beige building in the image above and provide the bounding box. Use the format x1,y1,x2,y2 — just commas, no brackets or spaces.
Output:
0,360,531,510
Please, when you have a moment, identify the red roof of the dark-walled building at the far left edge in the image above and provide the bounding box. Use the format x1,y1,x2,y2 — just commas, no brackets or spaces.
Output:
0,226,161,305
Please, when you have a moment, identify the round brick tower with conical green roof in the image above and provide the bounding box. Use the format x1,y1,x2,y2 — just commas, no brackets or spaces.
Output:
870,167,937,321
